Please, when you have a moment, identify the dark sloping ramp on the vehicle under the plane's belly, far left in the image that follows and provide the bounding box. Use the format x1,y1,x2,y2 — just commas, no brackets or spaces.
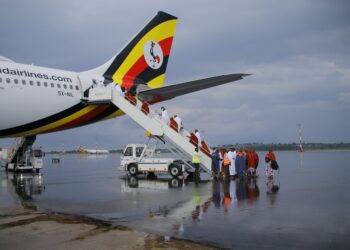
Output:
7,135,36,164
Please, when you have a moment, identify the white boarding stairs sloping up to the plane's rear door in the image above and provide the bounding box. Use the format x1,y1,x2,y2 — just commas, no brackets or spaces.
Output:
86,86,212,174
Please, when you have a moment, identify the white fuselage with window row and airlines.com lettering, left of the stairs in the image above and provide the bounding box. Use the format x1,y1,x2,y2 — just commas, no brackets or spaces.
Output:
0,57,117,137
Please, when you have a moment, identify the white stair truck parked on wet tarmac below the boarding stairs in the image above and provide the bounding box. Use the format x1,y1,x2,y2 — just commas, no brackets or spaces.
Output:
119,144,184,177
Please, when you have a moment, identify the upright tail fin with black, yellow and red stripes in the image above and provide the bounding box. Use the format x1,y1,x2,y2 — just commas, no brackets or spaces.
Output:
103,11,177,89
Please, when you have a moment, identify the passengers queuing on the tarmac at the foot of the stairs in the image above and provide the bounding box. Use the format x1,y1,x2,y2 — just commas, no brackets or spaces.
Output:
212,147,277,179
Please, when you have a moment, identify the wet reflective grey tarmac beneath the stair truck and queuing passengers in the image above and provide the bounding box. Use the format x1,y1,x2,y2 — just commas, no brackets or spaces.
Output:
0,151,350,249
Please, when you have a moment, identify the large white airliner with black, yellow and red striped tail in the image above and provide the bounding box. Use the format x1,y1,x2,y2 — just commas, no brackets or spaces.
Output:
0,11,249,146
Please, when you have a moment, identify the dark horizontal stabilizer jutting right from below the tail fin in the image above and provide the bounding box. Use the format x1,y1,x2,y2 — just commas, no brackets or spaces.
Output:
138,74,250,104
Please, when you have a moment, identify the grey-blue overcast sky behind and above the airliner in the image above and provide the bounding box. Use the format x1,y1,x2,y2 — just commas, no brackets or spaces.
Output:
0,0,350,150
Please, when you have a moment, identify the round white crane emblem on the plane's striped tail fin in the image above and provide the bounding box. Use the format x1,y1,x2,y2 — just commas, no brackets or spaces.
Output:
143,40,163,69
